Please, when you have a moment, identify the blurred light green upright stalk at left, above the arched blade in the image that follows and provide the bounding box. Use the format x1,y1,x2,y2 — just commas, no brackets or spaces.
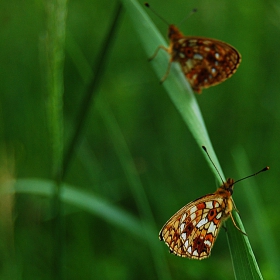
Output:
45,0,67,180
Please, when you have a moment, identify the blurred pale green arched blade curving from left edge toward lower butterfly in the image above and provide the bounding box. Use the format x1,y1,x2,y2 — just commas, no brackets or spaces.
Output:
1,178,153,245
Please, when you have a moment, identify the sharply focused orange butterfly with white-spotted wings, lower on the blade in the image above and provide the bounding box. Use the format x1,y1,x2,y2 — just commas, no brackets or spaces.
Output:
159,146,269,260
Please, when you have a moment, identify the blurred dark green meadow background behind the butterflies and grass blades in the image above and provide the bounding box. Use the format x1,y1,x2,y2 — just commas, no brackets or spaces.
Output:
0,0,280,279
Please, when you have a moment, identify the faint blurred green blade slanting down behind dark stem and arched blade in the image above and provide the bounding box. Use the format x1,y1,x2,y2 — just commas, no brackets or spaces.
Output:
65,14,171,280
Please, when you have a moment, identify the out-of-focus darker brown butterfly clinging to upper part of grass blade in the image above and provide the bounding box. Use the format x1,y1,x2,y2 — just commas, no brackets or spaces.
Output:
145,3,241,93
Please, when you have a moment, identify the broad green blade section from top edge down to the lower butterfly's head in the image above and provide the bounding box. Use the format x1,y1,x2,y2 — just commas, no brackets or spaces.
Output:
122,0,224,181
